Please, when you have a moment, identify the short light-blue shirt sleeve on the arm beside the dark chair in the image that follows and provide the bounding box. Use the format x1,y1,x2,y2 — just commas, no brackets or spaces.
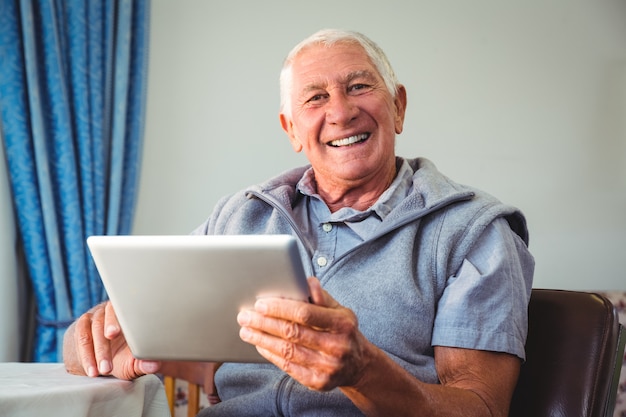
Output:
432,218,534,359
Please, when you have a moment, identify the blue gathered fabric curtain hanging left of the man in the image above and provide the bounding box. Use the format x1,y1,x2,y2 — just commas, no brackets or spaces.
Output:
0,0,149,362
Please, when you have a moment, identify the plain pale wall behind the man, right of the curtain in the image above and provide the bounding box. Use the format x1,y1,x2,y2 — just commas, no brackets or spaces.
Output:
134,0,626,289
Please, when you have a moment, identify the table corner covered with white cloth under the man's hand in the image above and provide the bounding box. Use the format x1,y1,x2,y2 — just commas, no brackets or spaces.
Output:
0,363,170,417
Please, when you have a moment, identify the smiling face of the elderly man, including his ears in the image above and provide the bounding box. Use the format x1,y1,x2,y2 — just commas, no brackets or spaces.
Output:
280,43,406,192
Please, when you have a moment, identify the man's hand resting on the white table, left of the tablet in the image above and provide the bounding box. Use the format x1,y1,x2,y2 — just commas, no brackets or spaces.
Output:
63,301,161,380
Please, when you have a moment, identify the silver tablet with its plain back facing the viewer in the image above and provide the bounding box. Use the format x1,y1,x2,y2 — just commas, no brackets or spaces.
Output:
87,235,308,362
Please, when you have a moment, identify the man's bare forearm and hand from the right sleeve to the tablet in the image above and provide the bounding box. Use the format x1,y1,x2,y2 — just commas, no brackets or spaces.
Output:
238,278,520,417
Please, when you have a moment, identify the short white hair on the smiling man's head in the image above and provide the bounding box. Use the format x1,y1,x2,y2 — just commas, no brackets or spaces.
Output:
280,29,400,115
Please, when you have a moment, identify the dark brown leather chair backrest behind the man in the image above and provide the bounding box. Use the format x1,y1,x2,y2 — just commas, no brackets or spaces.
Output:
509,289,625,417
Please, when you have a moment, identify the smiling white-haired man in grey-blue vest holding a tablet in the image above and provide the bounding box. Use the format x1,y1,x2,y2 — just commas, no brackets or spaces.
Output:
64,30,534,417
